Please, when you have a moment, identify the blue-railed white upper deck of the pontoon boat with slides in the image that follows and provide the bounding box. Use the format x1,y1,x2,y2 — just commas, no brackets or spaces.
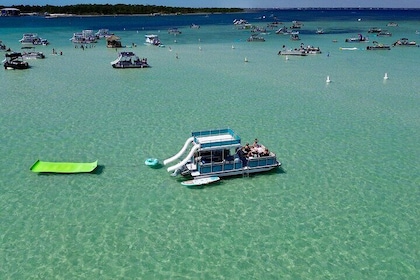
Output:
192,128,241,150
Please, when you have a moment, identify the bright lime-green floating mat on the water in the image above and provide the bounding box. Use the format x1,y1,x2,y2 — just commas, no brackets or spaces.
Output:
31,160,98,173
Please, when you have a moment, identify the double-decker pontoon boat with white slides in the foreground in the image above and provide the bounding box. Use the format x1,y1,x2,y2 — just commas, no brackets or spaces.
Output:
163,128,281,179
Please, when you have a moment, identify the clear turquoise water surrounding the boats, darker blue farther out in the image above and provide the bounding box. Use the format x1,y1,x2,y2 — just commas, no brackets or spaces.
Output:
0,10,420,279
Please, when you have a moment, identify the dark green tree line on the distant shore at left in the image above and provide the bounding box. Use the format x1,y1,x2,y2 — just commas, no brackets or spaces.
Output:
2,4,243,15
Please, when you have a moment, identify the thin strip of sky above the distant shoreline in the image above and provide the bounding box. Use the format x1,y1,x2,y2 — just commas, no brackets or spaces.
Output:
0,0,420,8
